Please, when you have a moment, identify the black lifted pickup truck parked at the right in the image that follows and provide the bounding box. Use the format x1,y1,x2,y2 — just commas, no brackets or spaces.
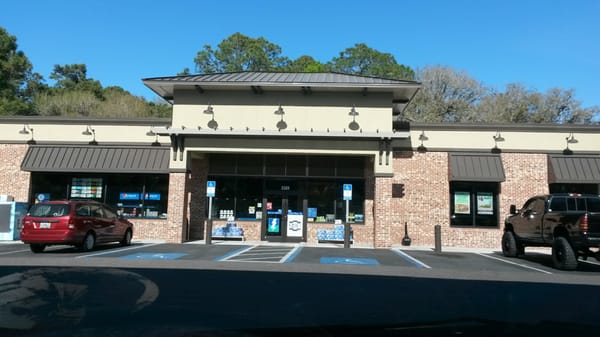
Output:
502,194,600,270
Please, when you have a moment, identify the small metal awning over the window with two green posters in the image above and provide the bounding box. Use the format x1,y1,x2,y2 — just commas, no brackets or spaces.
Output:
449,153,506,182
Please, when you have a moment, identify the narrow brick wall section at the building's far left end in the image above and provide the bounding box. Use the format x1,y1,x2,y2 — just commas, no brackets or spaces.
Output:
0,144,31,202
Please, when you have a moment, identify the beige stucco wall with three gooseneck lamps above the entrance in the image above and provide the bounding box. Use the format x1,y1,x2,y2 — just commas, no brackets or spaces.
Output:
173,90,392,134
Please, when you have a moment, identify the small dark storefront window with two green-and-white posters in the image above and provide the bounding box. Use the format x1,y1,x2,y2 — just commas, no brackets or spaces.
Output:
450,181,499,227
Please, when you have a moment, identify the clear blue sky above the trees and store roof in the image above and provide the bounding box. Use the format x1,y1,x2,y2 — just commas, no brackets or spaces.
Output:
0,0,600,107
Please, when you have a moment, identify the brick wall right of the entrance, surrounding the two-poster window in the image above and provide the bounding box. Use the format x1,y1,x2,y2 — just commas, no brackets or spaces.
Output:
386,152,548,248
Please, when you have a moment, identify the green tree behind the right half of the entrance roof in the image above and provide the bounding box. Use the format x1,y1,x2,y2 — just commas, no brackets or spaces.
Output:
329,43,415,80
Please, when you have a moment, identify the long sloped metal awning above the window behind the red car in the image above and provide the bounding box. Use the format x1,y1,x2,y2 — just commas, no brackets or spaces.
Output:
21,145,169,173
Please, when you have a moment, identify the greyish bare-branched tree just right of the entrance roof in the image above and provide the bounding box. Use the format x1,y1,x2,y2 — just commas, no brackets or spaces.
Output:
405,66,486,122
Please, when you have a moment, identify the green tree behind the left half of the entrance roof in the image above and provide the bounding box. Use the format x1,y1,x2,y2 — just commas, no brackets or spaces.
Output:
194,33,288,74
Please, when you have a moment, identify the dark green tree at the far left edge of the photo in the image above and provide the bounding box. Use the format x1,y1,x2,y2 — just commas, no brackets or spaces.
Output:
0,27,33,115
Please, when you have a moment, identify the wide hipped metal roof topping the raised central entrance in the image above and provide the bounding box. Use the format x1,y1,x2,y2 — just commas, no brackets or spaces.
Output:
142,72,421,103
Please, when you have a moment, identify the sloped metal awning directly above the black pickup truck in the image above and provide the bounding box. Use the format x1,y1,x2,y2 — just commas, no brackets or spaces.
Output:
548,155,600,184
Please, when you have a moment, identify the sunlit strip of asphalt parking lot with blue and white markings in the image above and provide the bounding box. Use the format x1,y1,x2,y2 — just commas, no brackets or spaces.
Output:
0,242,600,279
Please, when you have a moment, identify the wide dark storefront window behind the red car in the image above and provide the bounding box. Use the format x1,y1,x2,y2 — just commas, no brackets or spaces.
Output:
31,172,169,218
